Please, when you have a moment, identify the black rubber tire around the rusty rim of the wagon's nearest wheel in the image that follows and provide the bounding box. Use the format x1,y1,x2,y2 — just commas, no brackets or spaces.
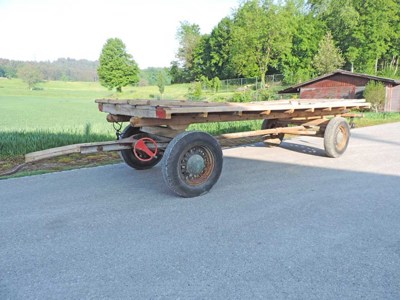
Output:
162,131,223,198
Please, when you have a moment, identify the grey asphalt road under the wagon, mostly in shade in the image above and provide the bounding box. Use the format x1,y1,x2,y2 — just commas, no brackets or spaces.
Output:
0,123,400,300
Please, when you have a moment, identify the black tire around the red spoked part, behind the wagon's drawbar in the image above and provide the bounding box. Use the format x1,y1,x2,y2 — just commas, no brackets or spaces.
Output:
119,125,162,170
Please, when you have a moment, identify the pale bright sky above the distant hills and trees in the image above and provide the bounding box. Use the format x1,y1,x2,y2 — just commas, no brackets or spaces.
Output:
0,0,239,69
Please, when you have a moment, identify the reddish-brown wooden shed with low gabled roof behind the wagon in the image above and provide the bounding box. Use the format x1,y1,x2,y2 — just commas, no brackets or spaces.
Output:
279,70,400,112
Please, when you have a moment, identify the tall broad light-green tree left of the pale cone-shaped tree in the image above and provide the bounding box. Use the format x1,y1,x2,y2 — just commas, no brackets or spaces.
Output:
232,0,293,83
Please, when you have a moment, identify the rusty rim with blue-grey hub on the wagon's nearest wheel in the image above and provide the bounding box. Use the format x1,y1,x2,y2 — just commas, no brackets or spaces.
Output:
179,146,215,185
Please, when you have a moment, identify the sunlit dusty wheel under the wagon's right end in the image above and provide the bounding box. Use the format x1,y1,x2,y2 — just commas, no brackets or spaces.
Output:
324,117,350,158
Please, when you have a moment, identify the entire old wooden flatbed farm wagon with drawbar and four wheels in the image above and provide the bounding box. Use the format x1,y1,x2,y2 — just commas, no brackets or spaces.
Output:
26,99,370,197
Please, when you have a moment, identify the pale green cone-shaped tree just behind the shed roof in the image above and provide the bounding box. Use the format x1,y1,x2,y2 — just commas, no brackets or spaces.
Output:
313,31,344,74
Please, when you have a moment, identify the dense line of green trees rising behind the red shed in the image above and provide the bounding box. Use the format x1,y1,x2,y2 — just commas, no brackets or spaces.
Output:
170,0,400,83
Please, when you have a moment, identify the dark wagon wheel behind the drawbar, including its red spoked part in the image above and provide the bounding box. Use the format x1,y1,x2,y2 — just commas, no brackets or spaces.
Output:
119,125,162,170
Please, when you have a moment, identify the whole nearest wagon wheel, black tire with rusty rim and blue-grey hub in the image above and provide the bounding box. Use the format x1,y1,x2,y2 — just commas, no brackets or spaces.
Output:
162,131,223,197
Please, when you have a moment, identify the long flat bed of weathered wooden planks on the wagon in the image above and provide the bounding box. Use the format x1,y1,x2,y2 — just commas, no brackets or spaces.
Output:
96,99,370,127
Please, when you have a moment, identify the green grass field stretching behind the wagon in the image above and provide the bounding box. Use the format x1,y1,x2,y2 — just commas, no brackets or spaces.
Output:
0,79,400,161
